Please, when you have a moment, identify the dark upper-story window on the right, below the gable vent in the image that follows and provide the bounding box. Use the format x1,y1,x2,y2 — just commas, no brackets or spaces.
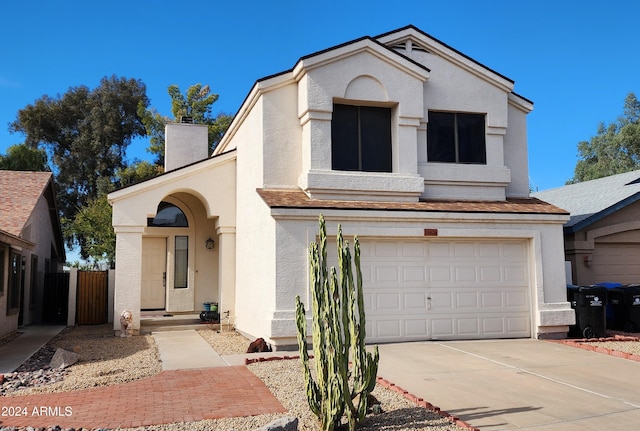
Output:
427,111,487,165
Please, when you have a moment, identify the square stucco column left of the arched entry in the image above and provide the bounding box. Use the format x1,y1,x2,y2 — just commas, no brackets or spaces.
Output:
113,226,144,333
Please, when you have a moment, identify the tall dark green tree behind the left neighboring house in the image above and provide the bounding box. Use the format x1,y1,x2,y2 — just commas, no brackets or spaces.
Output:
10,76,148,230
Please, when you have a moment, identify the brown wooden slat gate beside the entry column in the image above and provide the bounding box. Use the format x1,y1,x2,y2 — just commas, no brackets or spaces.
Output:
76,271,109,325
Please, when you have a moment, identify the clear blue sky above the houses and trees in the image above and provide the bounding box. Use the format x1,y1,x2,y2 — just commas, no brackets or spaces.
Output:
0,0,640,190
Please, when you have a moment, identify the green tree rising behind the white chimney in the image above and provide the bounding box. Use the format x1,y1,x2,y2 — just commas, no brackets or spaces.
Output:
138,84,233,165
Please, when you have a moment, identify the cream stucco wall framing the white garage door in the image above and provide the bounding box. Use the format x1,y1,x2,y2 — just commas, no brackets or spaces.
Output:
254,209,574,346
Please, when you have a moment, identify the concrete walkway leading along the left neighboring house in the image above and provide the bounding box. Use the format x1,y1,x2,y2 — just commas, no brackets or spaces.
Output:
0,325,65,374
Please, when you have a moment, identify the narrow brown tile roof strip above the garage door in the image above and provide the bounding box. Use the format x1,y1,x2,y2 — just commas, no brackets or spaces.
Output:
256,189,569,215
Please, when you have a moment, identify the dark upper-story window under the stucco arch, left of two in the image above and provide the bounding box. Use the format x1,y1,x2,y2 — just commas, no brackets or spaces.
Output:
331,104,391,172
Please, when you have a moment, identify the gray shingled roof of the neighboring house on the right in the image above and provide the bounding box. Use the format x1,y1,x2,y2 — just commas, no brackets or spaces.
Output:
532,170,640,232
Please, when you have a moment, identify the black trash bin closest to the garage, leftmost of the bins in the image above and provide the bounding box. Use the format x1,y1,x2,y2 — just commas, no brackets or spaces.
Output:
567,285,607,338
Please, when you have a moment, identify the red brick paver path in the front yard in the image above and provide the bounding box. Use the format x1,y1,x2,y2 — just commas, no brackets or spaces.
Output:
0,366,286,429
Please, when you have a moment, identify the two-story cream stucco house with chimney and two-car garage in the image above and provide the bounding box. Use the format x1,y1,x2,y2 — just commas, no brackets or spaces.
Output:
110,26,574,348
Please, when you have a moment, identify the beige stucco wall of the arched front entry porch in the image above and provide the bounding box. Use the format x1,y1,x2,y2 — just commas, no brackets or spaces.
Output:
109,152,236,330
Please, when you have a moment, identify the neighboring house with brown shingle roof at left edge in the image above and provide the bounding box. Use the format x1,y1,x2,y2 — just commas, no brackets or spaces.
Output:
0,170,65,337
